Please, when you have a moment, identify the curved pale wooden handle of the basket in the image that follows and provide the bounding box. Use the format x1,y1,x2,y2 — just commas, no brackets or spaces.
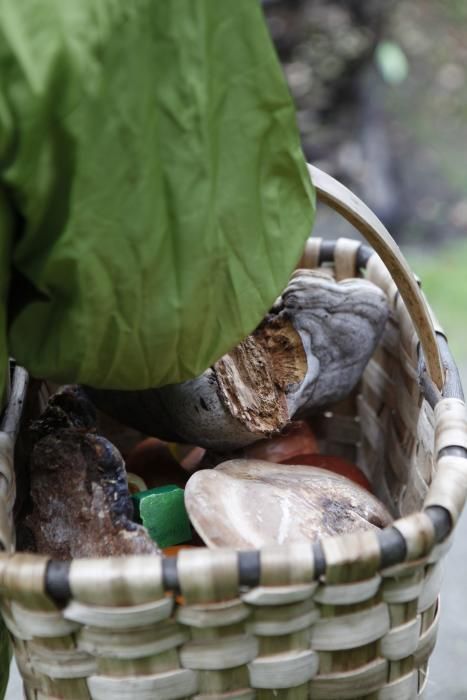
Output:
308,165,444,390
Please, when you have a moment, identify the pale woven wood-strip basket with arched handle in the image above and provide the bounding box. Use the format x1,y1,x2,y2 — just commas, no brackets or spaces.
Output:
0,168,467,700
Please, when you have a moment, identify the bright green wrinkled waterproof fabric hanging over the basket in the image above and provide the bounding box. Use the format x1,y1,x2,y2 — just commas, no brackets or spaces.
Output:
0,0,314,400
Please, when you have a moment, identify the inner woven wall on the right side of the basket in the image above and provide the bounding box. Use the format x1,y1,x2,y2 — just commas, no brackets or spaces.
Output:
318,256,436,517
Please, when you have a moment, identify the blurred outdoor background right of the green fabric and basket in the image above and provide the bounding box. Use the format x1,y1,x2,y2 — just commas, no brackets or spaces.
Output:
263,0,467,700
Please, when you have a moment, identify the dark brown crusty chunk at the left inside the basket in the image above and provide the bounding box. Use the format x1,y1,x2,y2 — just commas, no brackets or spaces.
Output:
19,387,157,559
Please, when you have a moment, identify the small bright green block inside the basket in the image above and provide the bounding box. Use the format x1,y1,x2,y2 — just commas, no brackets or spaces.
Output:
132,484,192,548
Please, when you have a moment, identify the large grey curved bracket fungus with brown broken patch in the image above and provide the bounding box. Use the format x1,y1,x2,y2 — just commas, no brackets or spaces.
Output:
89,270,388,451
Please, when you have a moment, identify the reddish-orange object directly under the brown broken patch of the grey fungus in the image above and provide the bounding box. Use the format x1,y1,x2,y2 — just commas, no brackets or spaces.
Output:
244,421,319,464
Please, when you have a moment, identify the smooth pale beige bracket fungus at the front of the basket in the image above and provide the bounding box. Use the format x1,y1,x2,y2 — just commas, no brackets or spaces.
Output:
185,459,392,549
